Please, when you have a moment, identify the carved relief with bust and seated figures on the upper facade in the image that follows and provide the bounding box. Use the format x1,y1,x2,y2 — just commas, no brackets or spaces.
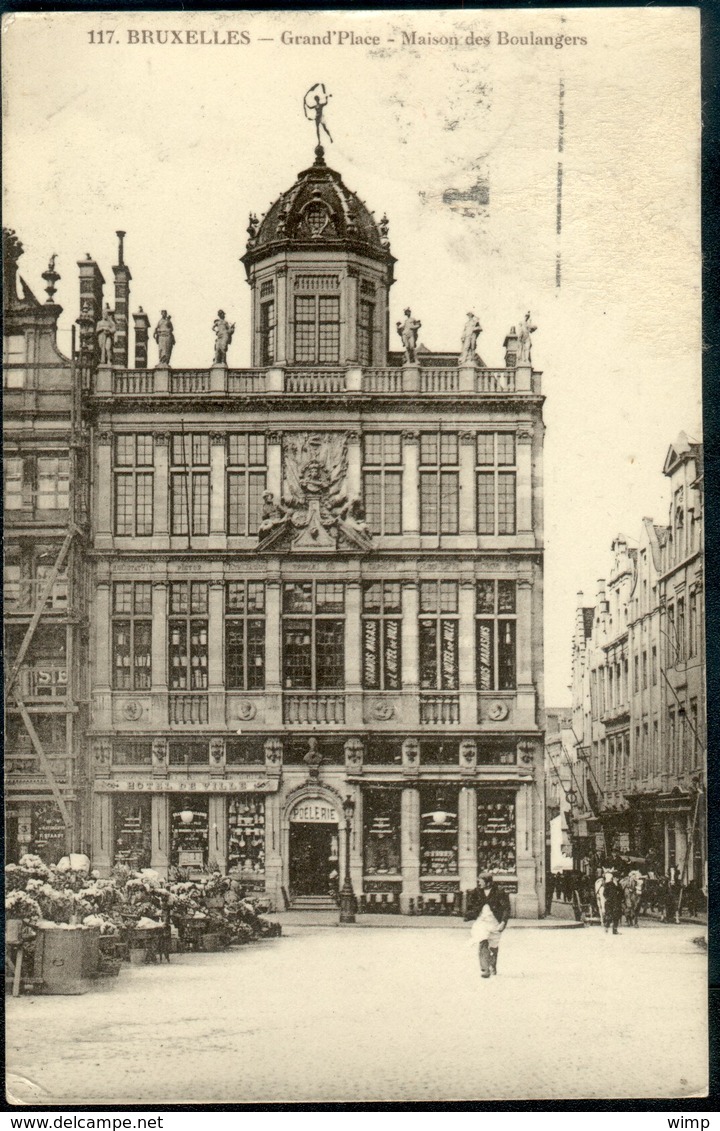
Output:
258,432,371,552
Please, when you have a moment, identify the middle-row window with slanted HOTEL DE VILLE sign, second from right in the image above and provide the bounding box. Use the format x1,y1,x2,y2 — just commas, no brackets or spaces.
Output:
419,581,459,691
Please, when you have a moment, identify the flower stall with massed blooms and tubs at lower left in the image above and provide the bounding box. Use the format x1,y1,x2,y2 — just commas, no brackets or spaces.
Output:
5,855,280,993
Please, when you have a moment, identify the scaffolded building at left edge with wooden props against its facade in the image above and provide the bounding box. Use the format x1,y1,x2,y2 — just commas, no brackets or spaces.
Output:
2,230,88,862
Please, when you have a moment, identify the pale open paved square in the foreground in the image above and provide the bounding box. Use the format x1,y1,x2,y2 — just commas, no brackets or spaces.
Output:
7,923,706,1107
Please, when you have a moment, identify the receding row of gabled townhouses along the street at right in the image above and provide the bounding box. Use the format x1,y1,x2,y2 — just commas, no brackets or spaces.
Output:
573,433,706,886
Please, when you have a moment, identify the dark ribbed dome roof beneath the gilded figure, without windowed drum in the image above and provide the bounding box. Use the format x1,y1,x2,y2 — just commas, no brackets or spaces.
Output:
242,146,393,268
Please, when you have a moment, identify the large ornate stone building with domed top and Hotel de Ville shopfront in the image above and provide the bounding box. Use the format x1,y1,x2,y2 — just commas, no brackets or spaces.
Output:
4,141,545,917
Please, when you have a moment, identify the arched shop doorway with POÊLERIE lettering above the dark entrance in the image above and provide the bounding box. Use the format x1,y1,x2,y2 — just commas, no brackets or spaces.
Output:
288,796,340,898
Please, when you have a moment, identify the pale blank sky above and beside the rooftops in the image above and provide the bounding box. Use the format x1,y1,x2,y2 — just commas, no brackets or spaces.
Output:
2,8,701,706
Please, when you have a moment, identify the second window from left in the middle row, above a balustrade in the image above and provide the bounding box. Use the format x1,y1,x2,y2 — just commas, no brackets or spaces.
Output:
167,581,208,691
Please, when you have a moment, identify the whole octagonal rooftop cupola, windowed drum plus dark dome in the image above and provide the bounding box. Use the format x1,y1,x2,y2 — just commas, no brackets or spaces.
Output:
242,146,394,366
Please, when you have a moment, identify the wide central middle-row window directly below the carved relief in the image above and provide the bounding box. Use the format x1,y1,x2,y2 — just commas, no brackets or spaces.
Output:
283,581,345,691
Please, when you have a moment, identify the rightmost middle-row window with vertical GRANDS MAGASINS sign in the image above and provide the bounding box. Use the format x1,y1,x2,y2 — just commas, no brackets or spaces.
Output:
475,581,517,691
